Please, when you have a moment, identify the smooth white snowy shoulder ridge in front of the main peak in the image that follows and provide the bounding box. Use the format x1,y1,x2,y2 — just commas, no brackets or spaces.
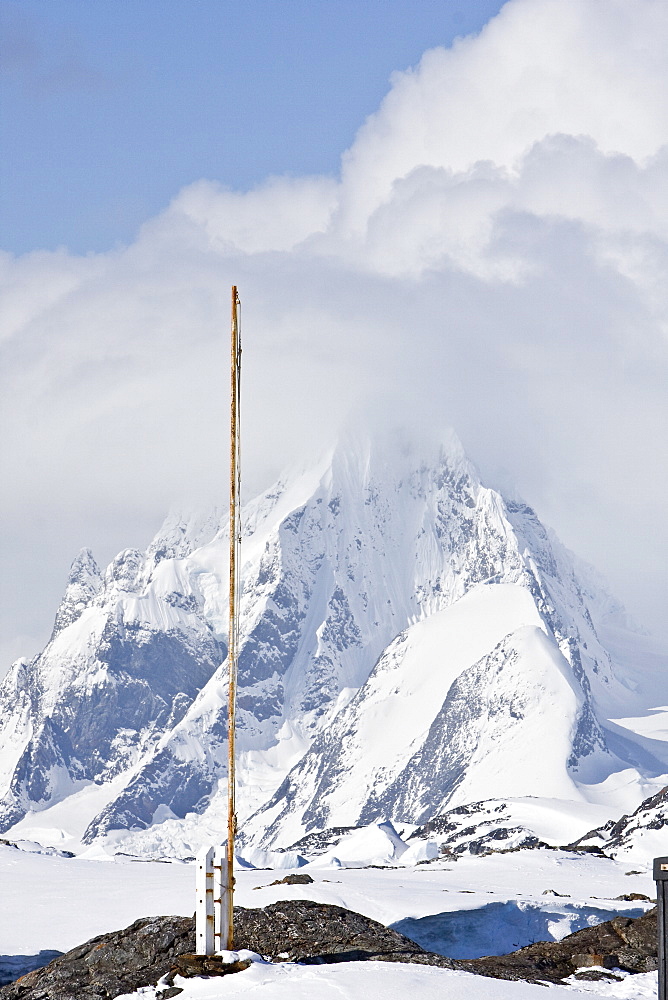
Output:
246,584,608,843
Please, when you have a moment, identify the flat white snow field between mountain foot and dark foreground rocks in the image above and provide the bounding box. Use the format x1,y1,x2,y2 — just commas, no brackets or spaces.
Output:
0,846,654,955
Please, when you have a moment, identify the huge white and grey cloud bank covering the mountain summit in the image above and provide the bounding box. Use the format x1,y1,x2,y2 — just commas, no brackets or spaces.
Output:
0,0,668,669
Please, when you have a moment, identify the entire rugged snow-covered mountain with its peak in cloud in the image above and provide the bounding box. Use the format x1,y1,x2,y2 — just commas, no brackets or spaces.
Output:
0,426,668,854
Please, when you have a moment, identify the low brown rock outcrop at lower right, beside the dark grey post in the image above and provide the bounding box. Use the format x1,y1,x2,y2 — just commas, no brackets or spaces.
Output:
457,909,658,983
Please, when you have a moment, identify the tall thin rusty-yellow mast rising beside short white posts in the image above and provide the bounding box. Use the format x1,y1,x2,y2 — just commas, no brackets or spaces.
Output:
226,285,241,951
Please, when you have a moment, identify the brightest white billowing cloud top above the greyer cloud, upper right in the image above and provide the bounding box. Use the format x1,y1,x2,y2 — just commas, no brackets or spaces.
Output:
342,0,668,232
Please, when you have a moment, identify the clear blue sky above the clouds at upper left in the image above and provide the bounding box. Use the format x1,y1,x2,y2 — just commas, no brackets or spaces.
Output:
0,0,502,253
